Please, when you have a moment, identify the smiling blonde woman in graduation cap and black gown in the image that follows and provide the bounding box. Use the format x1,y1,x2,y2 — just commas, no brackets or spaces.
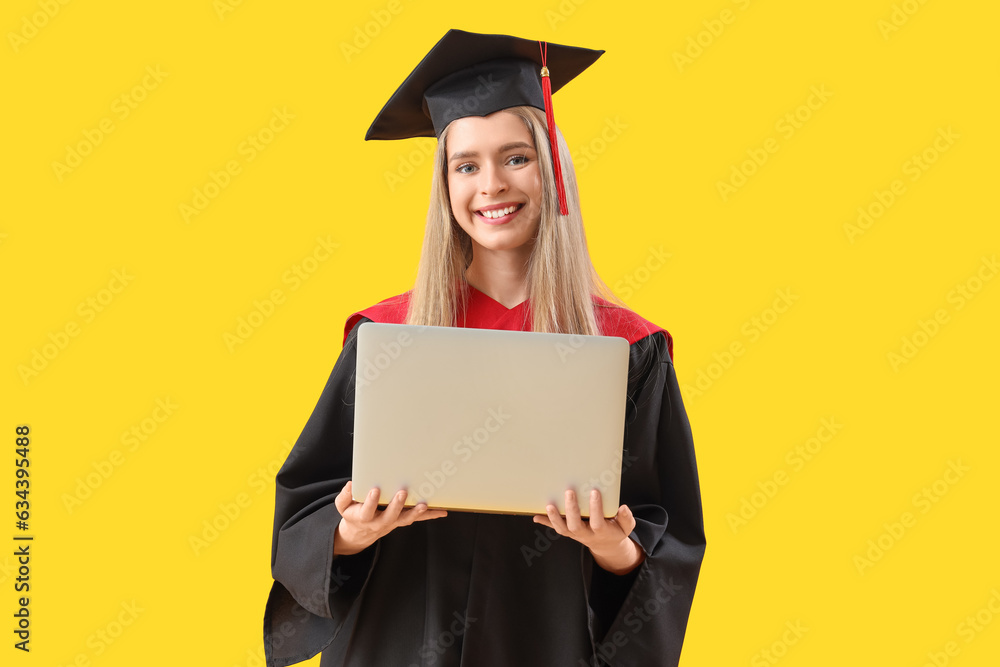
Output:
264,30,705,667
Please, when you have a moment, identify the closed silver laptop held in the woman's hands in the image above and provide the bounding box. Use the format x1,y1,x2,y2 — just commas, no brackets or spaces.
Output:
352,322,629,517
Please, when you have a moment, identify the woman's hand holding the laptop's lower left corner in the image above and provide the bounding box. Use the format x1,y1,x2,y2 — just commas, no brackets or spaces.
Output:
333,482,448,556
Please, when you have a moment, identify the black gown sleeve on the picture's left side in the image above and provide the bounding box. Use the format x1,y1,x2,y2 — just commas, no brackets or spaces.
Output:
264,318,378,667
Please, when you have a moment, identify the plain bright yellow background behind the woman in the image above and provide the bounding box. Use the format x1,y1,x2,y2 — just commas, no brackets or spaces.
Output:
0,0,1000,667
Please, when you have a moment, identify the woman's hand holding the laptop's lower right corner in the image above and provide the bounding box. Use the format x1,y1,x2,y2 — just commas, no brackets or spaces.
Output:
534,489,646,574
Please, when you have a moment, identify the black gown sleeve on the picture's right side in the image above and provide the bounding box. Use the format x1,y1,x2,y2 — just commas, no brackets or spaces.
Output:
584,332,705,667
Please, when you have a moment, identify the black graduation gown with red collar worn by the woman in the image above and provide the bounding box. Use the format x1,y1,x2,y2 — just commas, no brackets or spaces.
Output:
264,287,705,667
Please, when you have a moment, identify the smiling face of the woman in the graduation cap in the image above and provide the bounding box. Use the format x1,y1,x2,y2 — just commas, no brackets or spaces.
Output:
446,111,542,251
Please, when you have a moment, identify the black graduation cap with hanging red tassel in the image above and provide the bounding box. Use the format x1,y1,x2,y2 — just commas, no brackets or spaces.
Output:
365,30,604,215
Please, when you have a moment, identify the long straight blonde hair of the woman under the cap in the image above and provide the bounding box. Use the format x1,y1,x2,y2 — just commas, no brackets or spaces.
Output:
406,106,625,335
